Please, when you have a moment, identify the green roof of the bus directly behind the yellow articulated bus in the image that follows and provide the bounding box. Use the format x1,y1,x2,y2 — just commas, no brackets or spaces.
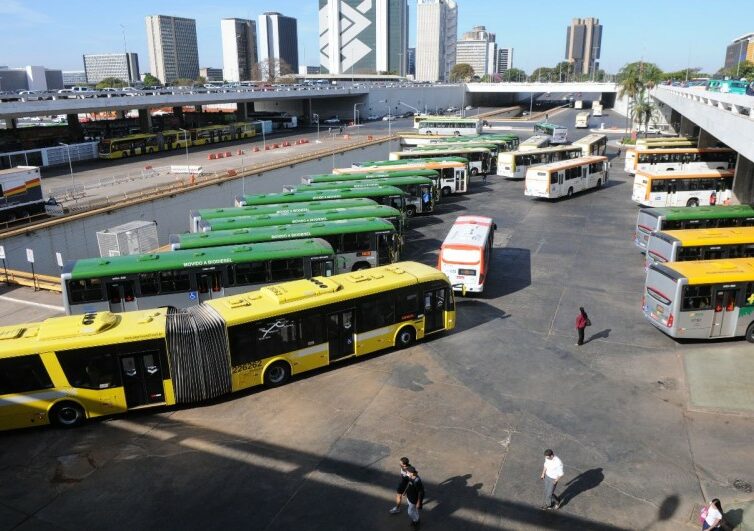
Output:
63,238,333,280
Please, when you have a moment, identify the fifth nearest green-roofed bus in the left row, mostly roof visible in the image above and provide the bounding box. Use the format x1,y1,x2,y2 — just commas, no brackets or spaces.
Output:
236,186,406,214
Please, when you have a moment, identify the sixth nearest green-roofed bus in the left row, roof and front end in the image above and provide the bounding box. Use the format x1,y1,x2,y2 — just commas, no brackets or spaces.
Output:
283,176,438,217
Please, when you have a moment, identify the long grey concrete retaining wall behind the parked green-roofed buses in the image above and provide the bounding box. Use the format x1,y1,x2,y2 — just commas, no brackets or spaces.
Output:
0,141,399,275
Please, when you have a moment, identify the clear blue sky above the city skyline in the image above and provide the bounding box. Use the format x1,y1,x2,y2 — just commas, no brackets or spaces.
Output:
0,0,754,73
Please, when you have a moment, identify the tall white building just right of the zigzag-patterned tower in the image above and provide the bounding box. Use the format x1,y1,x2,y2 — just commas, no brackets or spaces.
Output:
416,0,458,81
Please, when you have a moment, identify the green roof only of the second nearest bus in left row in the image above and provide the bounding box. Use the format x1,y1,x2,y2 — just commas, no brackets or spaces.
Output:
170,218,395,249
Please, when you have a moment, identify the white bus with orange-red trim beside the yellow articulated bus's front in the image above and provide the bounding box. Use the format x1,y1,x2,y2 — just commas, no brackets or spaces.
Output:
437,216,497,293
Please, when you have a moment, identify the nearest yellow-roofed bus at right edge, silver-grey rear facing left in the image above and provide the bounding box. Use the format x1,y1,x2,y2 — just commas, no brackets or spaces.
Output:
642,258,754,343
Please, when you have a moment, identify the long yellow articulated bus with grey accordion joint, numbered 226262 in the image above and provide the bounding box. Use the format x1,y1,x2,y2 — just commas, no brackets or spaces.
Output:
0,262,456,430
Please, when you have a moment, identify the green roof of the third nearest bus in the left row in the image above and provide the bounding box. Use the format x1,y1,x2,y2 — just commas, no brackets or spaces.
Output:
201,205,402,231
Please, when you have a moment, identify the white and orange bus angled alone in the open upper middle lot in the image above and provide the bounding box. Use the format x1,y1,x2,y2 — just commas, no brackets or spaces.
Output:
524,156,608,199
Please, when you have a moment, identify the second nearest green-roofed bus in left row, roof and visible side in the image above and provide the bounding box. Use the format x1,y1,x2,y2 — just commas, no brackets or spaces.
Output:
170,218,401,273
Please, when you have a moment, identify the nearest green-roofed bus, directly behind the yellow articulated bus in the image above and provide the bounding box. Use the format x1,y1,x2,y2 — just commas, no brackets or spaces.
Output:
60,238,335,315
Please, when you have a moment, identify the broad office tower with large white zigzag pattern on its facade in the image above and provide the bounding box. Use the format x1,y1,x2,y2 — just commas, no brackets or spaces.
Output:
319,0,408,75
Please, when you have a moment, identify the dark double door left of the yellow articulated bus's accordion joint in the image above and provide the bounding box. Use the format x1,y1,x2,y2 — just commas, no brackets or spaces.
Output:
120,350,165,409
